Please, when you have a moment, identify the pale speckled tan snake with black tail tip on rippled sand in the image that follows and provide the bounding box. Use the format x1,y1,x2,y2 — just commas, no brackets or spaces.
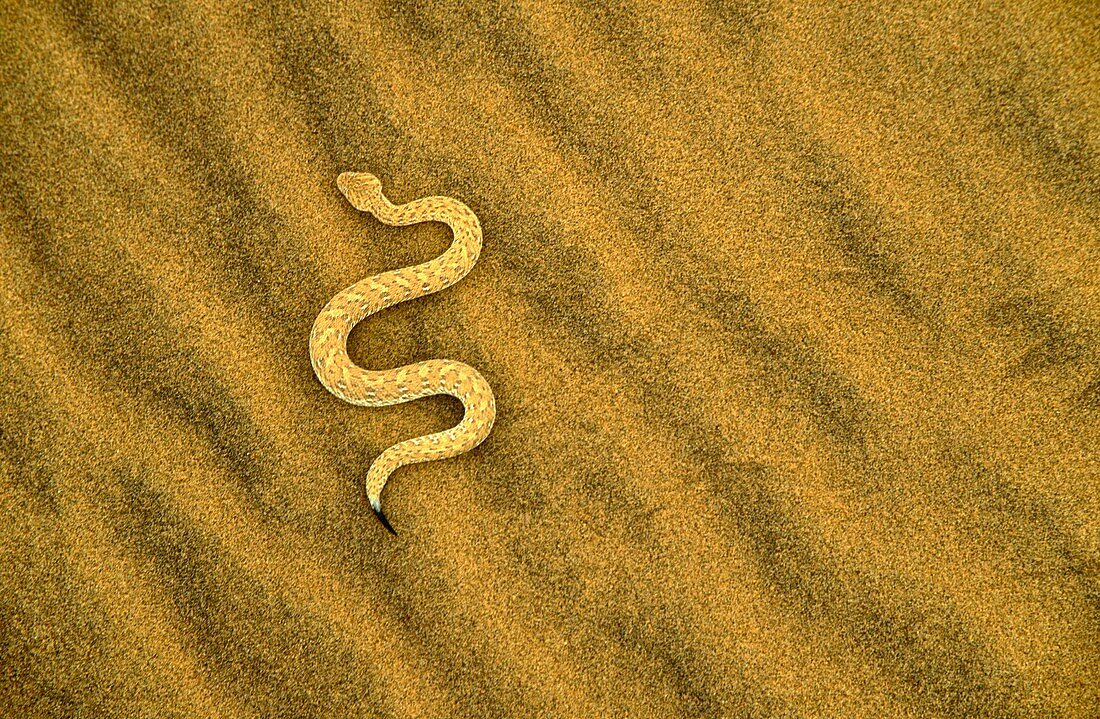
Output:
309,173,496,535
